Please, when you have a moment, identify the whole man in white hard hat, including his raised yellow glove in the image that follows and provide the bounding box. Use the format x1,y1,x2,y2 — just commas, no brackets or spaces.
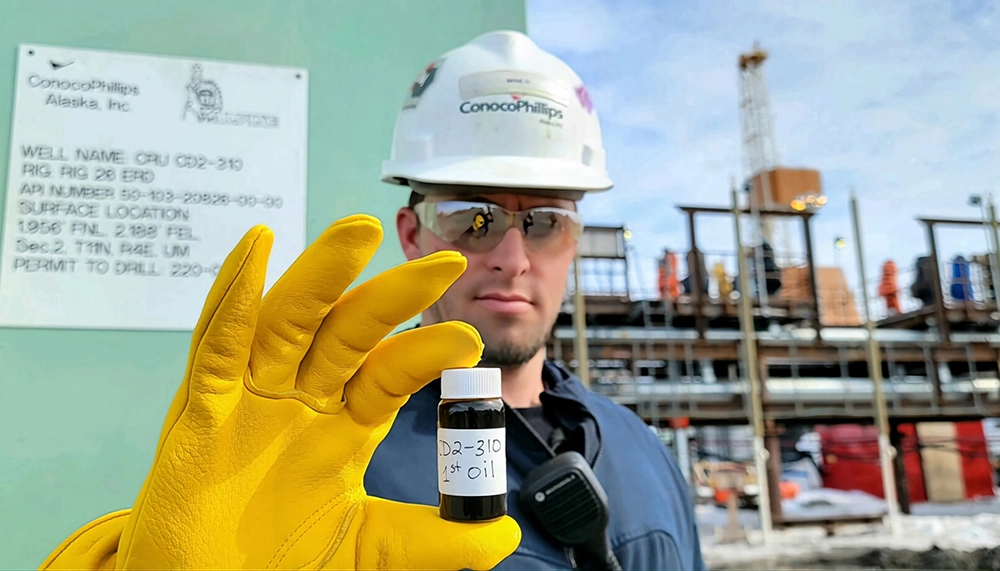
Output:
43,32,704,570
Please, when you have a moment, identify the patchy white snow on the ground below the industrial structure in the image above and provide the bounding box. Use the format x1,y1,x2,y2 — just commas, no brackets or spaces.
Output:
698,490,1000,567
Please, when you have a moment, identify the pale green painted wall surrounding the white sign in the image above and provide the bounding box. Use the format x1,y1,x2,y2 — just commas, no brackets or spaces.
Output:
0,0,525,569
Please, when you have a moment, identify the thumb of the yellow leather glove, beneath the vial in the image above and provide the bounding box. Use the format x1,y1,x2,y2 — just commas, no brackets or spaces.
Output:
358,498,521,571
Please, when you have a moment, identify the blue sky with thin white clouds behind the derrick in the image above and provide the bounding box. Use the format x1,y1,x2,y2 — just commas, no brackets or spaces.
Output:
527,0,1000,318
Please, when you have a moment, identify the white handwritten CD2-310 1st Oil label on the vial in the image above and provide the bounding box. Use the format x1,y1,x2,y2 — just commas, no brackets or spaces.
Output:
438,428,507,496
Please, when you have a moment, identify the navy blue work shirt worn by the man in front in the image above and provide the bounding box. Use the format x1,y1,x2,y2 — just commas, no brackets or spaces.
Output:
365,361,705,570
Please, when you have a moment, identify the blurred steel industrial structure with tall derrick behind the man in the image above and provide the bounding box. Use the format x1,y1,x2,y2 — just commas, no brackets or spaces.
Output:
548,45,1000,541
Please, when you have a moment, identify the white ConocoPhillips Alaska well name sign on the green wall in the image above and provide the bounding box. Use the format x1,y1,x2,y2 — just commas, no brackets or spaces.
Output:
0,45,309,330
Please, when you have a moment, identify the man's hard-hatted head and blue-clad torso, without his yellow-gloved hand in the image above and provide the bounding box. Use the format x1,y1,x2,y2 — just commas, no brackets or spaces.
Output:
365,32,704,569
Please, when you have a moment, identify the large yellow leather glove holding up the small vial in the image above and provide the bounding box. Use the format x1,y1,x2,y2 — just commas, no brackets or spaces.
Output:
42,216,520,570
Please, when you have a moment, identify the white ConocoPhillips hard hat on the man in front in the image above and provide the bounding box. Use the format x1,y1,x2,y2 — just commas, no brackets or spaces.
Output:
382,31,612,197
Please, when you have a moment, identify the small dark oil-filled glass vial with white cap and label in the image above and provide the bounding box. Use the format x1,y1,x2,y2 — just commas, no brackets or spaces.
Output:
438,368,507,522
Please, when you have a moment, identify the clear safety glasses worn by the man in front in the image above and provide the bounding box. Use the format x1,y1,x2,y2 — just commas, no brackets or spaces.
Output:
414,201,583,253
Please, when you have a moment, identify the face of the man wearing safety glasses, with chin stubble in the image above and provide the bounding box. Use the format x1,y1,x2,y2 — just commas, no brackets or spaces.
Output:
397,194,576,366
